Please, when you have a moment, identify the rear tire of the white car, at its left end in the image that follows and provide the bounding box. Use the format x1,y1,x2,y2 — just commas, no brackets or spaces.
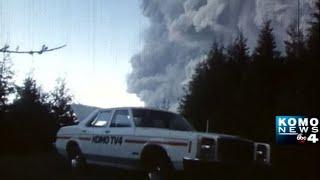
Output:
68,145,86,175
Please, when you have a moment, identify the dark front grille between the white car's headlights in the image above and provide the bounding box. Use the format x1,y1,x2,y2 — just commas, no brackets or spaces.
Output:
218,138,254,163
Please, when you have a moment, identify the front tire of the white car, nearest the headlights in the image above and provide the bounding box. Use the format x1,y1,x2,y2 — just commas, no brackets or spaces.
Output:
146,156,173,180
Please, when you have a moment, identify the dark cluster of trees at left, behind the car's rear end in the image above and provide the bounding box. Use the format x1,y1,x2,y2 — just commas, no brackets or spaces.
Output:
0,56,77,154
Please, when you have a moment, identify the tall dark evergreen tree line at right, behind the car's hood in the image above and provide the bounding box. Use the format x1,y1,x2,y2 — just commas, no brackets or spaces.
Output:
179,0,320,178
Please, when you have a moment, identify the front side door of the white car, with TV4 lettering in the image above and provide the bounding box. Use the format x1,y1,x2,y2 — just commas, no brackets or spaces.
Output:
104,109,134,165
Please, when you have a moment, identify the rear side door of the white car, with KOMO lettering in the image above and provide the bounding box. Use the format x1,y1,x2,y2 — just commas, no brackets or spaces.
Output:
80,110,112,162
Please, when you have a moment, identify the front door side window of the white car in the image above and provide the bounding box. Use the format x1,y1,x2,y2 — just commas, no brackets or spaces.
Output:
110,110,131,127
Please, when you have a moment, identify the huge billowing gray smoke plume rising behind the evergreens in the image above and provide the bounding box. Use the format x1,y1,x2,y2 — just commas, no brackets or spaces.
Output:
127,0,314,110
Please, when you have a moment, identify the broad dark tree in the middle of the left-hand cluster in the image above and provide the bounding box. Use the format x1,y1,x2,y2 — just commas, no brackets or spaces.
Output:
9,77,56,152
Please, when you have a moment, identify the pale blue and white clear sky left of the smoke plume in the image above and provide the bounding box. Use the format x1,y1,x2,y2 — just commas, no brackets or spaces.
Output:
0,0,148,108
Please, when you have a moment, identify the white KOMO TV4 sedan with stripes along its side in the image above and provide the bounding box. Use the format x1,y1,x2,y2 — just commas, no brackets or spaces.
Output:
55,108,270,179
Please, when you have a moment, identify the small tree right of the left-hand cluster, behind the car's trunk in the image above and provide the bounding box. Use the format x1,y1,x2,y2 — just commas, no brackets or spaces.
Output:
51,79,77,127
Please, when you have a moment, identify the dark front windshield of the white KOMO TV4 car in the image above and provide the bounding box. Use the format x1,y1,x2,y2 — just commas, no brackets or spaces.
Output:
132,109,194,131
